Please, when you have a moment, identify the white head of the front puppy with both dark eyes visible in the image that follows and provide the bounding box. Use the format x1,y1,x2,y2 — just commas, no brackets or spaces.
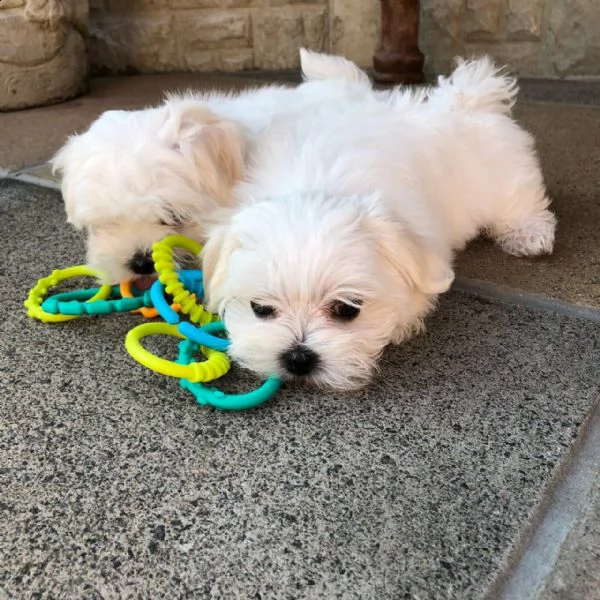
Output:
203,194,452,389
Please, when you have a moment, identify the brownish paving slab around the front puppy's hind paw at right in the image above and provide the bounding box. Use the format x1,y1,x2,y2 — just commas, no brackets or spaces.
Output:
457,99,600,308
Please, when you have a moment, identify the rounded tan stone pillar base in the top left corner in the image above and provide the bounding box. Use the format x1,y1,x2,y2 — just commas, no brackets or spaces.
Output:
0,0,88,110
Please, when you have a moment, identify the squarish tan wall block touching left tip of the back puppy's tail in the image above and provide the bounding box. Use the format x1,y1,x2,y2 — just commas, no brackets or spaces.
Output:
252,6,327,69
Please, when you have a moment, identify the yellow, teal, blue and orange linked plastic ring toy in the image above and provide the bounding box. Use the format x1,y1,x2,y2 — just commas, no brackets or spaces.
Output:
24,235,281,410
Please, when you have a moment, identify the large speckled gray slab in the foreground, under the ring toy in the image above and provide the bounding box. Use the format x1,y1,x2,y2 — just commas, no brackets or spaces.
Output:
0,181,600,600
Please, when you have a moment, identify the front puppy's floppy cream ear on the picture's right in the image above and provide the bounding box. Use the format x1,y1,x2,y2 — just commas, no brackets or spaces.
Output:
369,204,454,295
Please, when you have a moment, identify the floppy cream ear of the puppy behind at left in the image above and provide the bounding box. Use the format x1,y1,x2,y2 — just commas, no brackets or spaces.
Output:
159,97,244,198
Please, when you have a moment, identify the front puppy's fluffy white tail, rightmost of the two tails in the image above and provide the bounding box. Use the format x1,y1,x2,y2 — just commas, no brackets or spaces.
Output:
429,56,519,114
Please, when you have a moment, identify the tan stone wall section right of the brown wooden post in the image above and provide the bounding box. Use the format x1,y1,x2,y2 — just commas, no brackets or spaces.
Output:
421,0,600,77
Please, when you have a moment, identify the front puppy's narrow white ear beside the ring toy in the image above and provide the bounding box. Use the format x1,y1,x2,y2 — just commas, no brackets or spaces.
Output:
202,225,239,313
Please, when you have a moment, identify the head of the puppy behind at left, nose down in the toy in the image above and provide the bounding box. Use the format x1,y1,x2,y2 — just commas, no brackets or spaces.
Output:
52,97,244,282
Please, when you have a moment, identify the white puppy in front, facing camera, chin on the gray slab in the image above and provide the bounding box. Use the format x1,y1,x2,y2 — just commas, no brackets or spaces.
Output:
203,54,555,389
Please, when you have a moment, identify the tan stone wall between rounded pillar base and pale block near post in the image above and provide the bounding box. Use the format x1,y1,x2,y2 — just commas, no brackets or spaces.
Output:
90,0,329,72
